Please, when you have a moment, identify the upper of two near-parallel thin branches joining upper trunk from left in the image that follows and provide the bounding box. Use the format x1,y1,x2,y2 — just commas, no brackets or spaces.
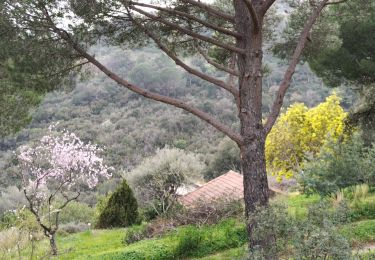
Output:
129,2,242,38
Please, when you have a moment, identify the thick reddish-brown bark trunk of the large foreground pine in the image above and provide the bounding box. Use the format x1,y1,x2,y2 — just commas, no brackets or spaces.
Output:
234,0,274,252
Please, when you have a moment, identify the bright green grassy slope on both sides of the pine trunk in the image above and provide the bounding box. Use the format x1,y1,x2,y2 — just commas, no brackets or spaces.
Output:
5,195,375,260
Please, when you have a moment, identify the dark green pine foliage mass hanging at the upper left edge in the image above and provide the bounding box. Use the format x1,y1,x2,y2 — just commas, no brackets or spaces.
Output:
0,1,83,138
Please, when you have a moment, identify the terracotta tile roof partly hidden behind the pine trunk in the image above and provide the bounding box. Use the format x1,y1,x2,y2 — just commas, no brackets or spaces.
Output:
180,171,243,206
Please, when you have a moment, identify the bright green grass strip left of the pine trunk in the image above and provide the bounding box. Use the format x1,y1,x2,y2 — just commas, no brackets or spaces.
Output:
7,219,247,260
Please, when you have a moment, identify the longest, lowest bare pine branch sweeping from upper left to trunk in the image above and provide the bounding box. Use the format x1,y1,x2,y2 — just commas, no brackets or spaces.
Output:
44,9,242,144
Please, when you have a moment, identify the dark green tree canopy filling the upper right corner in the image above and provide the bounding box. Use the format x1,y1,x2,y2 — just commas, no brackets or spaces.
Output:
274,0,375,145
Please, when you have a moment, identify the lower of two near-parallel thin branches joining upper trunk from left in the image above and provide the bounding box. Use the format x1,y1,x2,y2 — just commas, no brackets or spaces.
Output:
129,6,245,54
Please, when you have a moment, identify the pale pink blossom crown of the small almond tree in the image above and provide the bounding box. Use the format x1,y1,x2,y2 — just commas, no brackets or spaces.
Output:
18,125,113,199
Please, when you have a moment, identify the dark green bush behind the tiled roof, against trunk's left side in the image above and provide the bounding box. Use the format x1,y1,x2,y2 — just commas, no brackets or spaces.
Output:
203,138,241,180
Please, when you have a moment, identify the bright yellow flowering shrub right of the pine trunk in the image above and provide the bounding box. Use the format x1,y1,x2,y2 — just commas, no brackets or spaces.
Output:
265,94,347,181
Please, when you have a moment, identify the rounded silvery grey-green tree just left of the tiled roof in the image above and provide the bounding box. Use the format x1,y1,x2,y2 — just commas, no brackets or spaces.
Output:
128,148,204,215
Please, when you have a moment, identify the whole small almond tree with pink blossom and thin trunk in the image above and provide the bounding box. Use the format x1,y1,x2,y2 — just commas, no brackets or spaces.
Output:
18,126,112,255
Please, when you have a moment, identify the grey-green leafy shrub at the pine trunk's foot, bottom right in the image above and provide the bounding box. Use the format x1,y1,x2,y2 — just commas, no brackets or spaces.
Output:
250,202,351,259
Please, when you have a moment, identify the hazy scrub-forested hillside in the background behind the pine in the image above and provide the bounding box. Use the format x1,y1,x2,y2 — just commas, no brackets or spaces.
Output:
0,46,340,190
